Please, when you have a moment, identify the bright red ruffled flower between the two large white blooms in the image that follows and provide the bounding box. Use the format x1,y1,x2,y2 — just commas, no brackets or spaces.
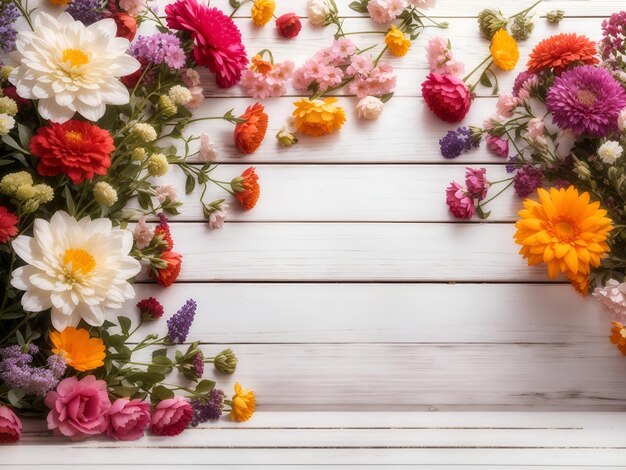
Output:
30,119,115,184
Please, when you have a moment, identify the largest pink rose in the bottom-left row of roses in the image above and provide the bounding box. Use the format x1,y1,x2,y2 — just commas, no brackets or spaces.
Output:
44,375,111,441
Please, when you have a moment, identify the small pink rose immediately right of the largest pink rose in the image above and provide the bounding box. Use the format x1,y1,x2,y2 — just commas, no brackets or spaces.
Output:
107,398,150,441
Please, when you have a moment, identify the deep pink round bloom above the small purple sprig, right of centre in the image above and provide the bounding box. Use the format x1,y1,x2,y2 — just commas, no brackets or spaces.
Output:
422,73,472,122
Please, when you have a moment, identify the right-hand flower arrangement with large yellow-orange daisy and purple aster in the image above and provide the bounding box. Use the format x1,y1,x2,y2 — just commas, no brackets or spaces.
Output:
440,12,626,354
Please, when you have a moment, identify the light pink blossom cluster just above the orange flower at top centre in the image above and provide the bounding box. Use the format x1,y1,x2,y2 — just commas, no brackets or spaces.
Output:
293,38,397,99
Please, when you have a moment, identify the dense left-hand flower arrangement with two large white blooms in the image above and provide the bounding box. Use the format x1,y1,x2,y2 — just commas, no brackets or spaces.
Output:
0,0,260,442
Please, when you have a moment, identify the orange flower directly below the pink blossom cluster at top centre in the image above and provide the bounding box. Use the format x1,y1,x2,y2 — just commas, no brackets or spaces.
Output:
292,98,346,137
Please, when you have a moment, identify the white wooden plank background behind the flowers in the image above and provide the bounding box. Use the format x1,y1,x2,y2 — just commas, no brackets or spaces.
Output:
7,0,626,464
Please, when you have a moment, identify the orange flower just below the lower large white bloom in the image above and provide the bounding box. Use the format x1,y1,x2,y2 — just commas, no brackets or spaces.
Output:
50,326,106,372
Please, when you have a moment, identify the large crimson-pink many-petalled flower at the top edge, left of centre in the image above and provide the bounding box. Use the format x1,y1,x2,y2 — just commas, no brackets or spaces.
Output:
165,0,248,88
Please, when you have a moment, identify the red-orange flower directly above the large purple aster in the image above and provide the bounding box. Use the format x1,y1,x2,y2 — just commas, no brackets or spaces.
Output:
528,33,598,75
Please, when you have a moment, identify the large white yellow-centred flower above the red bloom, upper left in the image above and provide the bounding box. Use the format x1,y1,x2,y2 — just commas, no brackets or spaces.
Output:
9,12,140,122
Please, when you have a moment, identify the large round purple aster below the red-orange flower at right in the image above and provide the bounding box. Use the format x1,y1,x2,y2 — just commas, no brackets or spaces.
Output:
546,65,626,137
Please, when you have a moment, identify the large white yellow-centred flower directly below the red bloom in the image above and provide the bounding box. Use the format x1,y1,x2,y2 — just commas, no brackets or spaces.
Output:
11,211,141,331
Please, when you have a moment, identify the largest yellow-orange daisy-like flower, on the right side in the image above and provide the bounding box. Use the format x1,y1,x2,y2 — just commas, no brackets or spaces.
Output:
515,186,613,282
